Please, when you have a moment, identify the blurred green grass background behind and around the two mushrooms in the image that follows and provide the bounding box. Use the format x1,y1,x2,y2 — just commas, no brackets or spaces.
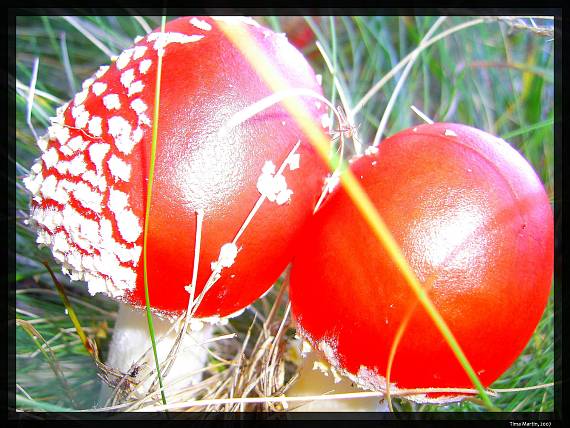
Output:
14,16,554,412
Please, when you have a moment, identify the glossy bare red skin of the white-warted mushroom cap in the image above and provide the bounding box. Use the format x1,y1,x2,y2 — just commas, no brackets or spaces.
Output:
36,17,328,316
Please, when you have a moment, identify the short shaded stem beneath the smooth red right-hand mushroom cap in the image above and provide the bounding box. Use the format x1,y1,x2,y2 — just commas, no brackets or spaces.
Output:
287,350,387,412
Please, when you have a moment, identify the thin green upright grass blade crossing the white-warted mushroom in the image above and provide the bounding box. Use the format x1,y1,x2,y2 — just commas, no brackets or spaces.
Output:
143,15,166,405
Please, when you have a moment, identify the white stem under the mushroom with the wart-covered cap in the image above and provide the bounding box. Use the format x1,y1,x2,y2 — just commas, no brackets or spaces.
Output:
99,303,213,403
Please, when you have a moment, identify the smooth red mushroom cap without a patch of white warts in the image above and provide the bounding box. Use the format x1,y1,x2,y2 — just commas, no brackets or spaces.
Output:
290,123,553,402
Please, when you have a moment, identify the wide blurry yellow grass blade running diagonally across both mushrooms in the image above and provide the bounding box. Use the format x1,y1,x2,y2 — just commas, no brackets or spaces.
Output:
220,19,497,410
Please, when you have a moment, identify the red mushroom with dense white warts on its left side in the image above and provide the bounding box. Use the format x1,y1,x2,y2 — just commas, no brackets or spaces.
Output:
25,17,326,398
